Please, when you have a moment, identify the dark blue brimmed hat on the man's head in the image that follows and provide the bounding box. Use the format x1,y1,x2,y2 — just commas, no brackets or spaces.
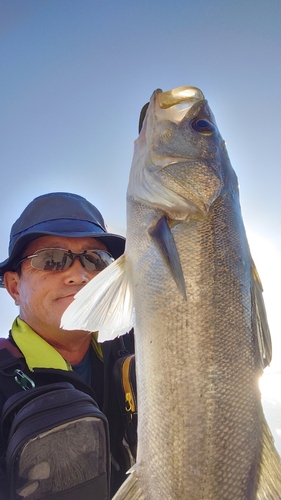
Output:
0,193,125,287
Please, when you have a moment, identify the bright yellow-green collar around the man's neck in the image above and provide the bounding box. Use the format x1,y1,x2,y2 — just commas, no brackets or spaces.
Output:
12,317,102,371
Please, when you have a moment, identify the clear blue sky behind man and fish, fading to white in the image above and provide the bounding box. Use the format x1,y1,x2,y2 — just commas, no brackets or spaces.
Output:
0,0,281,370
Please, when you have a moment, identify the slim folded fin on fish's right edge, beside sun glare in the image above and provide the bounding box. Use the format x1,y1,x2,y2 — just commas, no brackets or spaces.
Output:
252,261,272,368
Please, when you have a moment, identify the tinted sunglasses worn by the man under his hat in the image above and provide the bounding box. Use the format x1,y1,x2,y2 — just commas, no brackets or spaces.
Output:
16,248,114,271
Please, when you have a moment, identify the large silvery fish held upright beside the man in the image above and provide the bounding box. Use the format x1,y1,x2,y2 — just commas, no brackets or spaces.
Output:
61,87,281,500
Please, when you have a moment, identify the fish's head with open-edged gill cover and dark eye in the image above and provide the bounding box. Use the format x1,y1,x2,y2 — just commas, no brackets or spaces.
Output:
127,87,237,220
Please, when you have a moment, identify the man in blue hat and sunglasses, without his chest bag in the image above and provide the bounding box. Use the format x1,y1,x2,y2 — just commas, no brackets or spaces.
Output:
0,193,134,495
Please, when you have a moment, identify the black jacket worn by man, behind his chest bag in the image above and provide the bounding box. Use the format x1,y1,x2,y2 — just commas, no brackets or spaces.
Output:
0,331,134,500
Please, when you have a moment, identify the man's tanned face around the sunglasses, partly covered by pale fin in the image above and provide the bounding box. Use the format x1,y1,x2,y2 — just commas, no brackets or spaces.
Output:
5,236,107,340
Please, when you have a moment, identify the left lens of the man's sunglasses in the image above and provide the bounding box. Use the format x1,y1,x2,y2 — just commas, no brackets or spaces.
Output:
31,248,72,271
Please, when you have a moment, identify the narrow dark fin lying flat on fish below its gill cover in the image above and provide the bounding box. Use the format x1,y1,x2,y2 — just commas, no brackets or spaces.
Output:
149,215,186,300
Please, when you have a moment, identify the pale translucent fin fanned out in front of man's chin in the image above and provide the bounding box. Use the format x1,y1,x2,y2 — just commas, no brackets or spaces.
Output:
61,255,133,342
